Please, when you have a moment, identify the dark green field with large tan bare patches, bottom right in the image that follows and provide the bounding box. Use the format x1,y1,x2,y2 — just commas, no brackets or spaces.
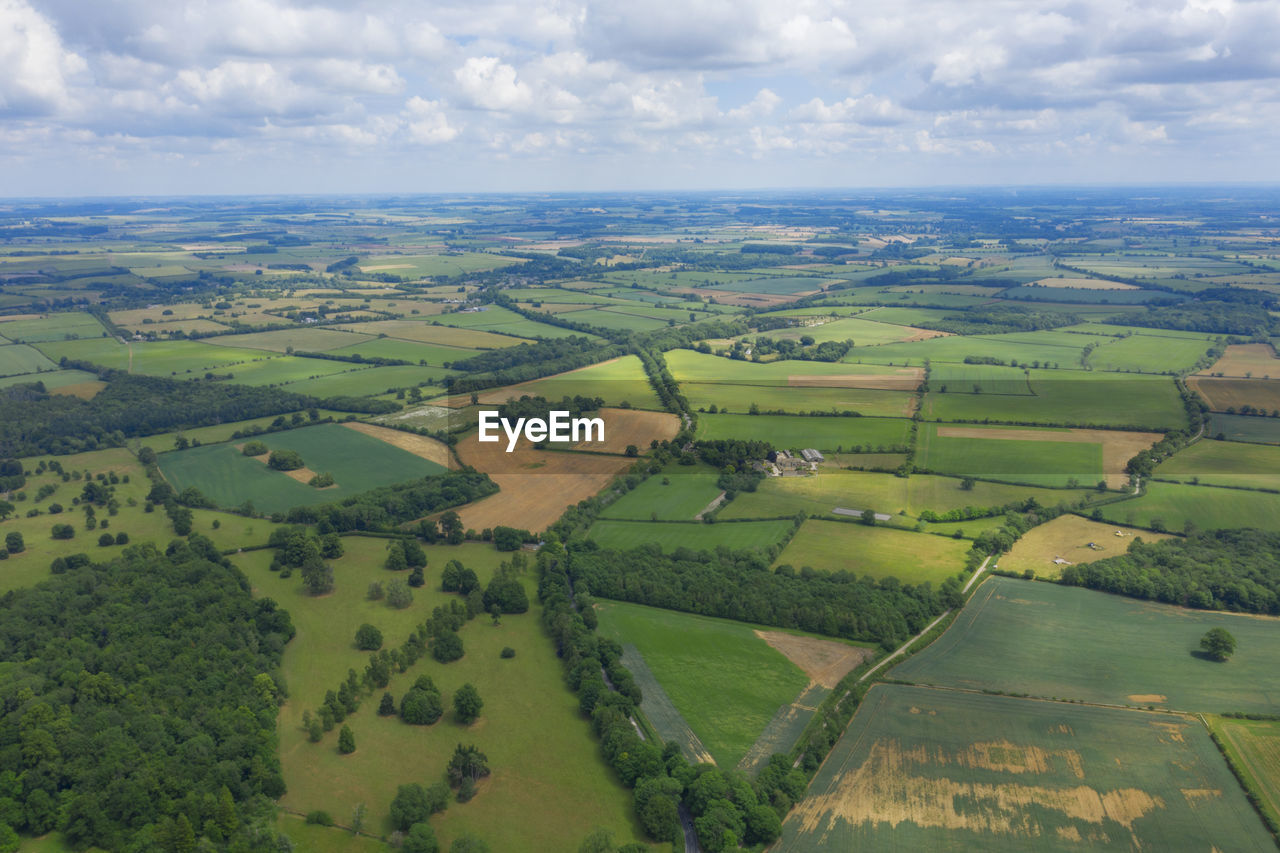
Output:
777,684,1274,853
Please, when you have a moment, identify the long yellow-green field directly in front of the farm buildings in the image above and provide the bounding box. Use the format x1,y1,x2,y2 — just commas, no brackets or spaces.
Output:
721,468,1089,525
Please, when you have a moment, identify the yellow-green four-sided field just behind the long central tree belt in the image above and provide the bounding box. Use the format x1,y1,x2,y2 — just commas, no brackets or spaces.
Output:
774,519,969,585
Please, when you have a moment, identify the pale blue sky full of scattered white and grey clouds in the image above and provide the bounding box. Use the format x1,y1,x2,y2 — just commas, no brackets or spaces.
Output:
0,0,1280,196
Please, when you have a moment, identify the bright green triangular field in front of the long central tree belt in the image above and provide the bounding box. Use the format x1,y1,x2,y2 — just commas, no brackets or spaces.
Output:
596,602,809,768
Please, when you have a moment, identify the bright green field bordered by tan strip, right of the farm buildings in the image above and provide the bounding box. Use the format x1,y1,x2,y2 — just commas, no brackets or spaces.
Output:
916,424,1103,485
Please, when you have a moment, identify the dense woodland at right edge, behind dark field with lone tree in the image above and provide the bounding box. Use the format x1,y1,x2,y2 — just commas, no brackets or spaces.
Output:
1062,529,1280,615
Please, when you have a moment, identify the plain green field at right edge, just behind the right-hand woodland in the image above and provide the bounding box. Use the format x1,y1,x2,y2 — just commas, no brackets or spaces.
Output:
1102,483,1280,532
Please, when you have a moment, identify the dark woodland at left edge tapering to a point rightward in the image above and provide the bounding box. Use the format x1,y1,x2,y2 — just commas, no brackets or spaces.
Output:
0,370,323,459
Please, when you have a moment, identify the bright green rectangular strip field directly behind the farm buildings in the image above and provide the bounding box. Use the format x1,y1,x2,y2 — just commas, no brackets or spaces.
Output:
698,414,911,451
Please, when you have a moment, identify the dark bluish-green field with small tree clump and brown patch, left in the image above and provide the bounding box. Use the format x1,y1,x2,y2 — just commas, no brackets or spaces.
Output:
160,424,444,512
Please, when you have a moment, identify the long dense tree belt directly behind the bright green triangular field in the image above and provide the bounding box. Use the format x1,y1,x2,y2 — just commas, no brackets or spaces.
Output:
568,543,959,648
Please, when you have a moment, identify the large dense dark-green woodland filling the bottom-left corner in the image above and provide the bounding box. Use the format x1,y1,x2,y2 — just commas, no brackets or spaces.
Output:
0,535,293,850
